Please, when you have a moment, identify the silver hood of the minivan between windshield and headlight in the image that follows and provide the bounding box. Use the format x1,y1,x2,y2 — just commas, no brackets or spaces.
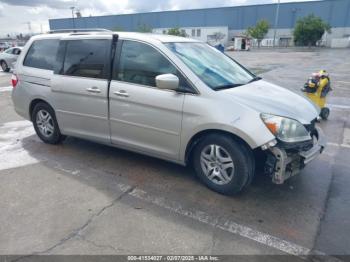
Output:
218,80,319,124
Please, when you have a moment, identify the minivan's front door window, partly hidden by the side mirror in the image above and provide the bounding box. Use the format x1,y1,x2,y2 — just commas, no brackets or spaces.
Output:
114,41,188,88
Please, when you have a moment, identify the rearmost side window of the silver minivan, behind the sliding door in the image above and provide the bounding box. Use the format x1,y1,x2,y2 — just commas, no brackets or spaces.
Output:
23,39,59,70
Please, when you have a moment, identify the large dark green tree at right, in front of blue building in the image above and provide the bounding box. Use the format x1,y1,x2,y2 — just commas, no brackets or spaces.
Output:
293,14,331,46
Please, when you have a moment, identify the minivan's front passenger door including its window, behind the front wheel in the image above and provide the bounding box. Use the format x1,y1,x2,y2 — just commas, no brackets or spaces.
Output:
110,41,190,160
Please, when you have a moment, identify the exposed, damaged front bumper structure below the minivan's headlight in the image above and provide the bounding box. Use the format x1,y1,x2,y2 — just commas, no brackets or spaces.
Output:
265,127,326,184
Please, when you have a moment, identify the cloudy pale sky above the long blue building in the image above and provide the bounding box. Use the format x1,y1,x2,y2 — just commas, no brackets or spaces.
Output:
0,0,318,36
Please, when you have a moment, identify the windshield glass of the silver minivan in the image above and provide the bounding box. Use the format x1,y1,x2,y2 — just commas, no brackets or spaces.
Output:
165,42,256,90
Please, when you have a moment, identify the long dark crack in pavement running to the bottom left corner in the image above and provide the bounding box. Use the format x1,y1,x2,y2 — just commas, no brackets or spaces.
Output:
12,186,136,262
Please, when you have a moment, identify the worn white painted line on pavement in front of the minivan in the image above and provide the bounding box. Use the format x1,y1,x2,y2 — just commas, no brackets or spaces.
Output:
129,189,311,256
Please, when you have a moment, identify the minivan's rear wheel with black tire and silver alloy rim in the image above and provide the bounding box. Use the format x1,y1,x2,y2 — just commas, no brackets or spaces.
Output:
32,103,65,145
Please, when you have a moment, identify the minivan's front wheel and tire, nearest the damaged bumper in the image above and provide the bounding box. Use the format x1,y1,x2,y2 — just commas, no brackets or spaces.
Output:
193,134,255,195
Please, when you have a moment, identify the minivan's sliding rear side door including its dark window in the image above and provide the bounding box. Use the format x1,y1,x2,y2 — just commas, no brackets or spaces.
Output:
52,37,111,142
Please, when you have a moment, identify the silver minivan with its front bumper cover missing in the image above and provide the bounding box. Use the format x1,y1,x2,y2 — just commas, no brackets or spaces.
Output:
12,30,324,194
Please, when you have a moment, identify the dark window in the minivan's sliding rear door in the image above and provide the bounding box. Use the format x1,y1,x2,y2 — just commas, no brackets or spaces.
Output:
63,39,110,78
